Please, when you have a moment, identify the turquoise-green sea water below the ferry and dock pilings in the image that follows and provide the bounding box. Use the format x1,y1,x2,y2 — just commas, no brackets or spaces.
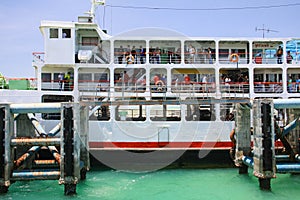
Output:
0,168,300,200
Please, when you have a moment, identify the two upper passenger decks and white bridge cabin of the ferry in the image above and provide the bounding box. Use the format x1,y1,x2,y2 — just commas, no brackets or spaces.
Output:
33,20,300,101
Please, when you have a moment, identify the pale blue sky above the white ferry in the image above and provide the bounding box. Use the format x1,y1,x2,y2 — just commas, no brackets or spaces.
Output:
0,0,300,78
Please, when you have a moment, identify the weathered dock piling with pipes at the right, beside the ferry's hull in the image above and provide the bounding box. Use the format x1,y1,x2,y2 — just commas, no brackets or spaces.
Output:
235,99,300,190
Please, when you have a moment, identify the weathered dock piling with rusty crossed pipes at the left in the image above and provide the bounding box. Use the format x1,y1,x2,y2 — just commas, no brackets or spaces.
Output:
0,103,90,195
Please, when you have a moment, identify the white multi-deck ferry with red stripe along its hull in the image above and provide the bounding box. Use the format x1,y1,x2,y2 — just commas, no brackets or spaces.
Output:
0,0,300,170
